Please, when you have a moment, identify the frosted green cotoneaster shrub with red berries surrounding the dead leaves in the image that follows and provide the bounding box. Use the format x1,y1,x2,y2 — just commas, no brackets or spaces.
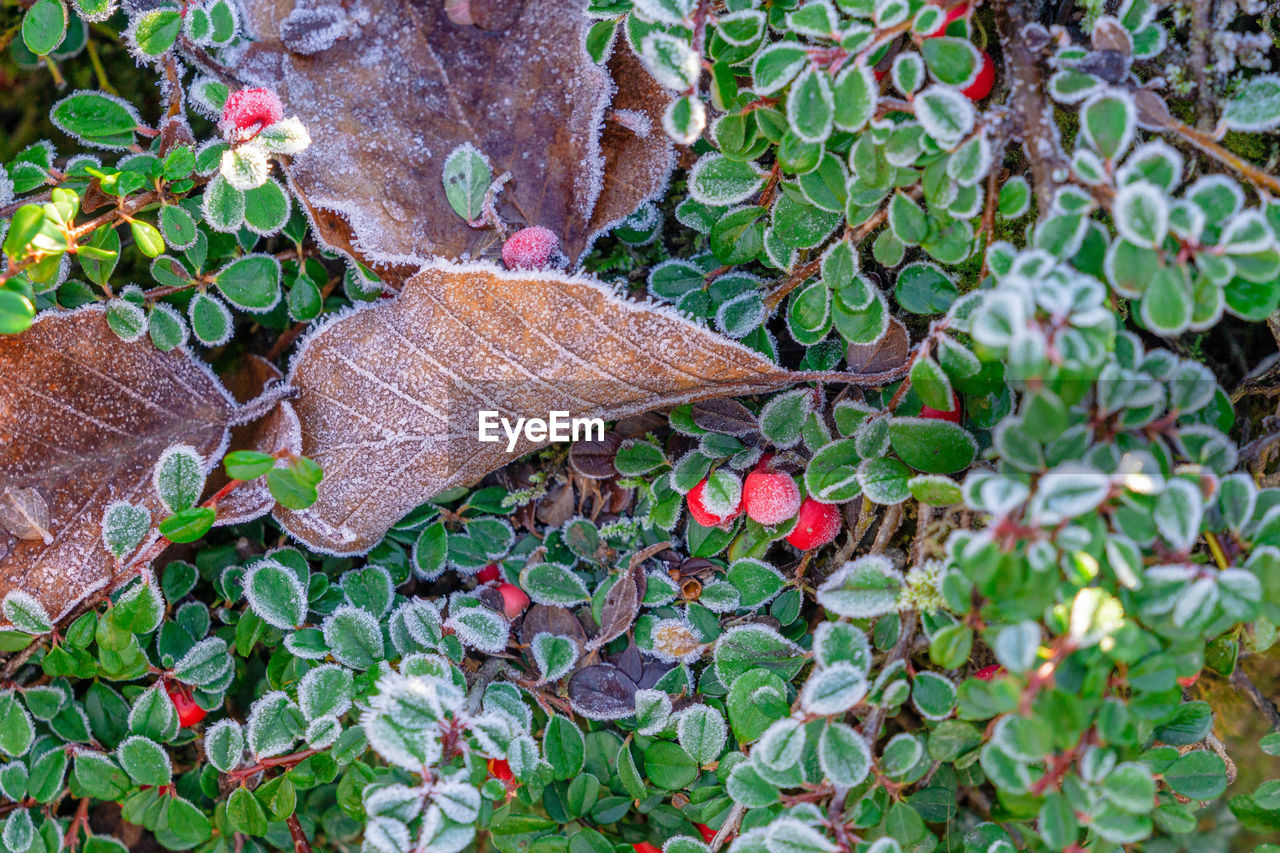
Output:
0,0,1280,853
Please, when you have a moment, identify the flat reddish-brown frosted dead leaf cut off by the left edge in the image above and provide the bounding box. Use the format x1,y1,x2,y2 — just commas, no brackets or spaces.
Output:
0,307,234,620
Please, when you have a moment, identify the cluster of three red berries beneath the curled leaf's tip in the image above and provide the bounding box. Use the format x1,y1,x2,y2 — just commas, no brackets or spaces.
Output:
686,456,840,551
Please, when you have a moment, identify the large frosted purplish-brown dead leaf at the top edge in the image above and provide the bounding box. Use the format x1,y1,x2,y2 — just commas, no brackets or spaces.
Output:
234,0,675,278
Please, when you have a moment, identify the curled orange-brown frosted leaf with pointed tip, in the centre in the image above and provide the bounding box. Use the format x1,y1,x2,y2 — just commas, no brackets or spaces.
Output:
276,264,804,555
